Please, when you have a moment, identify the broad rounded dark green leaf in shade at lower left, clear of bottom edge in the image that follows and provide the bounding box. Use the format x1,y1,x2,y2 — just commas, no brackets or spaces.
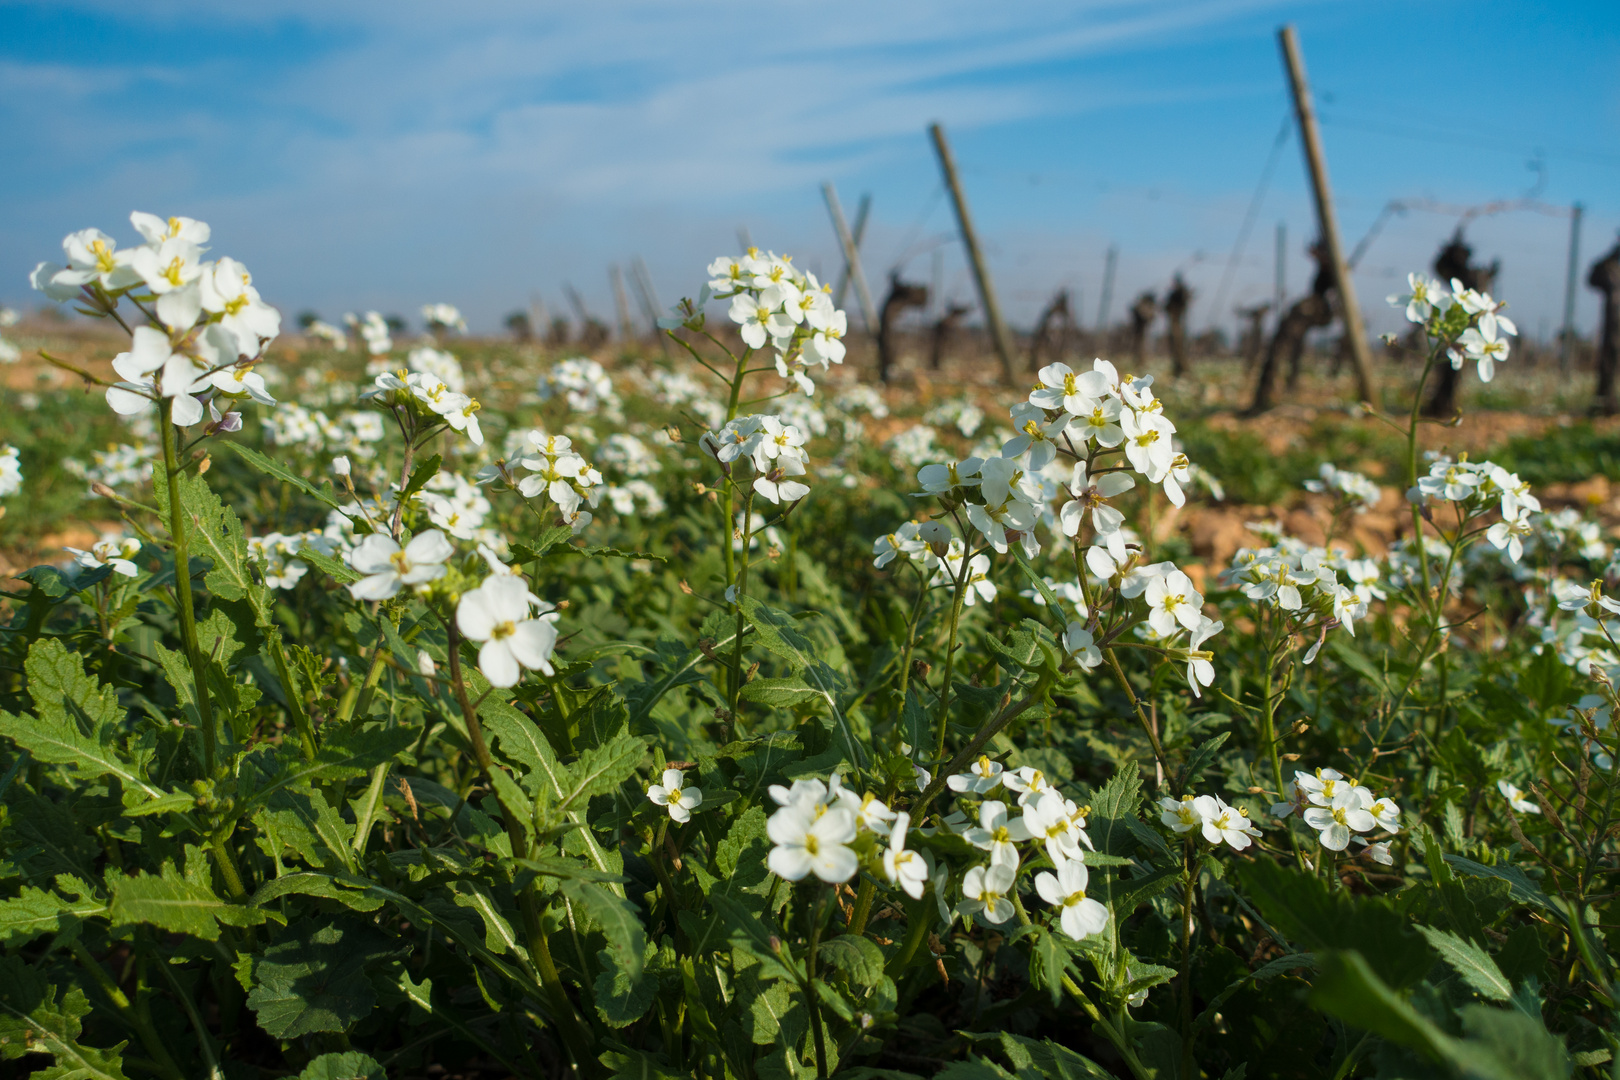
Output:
248,923,390,1040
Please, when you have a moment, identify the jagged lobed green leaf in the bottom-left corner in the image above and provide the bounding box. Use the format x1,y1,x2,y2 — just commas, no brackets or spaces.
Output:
0,957,126,1080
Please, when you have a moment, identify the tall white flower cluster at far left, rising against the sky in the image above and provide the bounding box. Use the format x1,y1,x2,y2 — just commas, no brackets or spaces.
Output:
32,212,282,431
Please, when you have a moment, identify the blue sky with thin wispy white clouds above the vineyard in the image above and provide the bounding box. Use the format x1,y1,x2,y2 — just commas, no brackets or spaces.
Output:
0,0,1620,334
